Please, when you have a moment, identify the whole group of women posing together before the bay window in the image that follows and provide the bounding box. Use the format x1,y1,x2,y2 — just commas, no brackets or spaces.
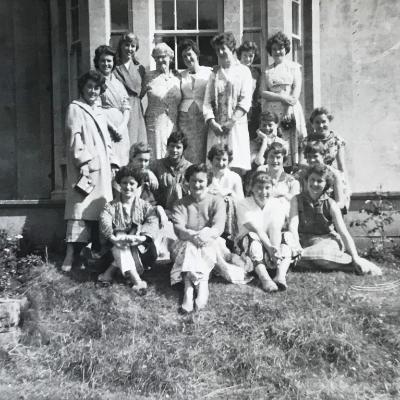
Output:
62,32,380,312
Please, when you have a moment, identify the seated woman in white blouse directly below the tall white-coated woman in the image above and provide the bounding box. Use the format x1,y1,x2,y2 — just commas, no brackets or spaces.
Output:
207,144,244,248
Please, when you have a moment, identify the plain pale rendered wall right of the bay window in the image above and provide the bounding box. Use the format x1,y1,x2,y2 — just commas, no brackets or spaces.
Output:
320,0,400,193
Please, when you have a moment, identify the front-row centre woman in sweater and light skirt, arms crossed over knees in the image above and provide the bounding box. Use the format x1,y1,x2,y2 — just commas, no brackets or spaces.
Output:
171,164,226,313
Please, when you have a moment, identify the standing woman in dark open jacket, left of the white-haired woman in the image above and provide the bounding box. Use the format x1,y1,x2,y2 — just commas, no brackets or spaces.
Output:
114,32,147,146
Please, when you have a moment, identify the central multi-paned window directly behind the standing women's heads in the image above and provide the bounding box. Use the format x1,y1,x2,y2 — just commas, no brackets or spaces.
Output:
154,0,223,69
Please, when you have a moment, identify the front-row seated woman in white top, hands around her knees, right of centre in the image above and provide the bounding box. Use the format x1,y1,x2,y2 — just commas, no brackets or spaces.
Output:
237,171,292,292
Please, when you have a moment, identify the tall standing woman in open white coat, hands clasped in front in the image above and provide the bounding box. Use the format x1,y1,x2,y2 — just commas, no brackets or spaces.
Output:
203,32,253,173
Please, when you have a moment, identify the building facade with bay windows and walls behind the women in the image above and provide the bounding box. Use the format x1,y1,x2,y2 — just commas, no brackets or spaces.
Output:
0,0,400,242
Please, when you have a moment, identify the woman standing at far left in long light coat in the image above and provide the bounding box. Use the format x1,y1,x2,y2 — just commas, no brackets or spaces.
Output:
61,71,118,272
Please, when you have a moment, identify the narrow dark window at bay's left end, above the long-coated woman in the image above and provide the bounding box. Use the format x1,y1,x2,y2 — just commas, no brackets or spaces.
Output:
67,0,83,100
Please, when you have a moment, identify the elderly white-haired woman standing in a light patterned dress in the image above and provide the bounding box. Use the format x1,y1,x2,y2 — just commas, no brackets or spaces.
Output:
145,43,181,159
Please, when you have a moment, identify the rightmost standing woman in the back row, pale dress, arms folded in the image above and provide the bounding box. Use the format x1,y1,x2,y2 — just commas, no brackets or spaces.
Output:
260,32,307,166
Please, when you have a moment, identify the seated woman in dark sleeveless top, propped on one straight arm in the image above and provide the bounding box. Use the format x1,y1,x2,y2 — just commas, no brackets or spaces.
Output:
289,164,382,275
